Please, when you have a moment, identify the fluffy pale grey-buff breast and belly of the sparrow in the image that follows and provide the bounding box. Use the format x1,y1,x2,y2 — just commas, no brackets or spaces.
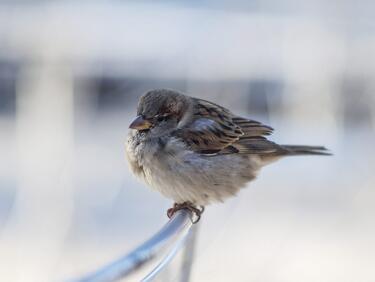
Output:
128,132,259,205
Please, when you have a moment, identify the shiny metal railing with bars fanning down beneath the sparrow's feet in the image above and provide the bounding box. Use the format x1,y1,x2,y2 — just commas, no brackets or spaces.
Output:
70,210,196,282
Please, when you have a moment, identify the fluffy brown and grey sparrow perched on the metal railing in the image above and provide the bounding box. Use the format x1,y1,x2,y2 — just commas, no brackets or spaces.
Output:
126,89,330,222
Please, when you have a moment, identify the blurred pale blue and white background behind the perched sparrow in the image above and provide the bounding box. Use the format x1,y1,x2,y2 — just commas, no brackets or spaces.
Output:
0,0,375,282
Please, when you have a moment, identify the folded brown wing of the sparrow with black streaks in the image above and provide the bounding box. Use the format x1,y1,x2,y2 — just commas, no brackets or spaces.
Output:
175,99,281,154
